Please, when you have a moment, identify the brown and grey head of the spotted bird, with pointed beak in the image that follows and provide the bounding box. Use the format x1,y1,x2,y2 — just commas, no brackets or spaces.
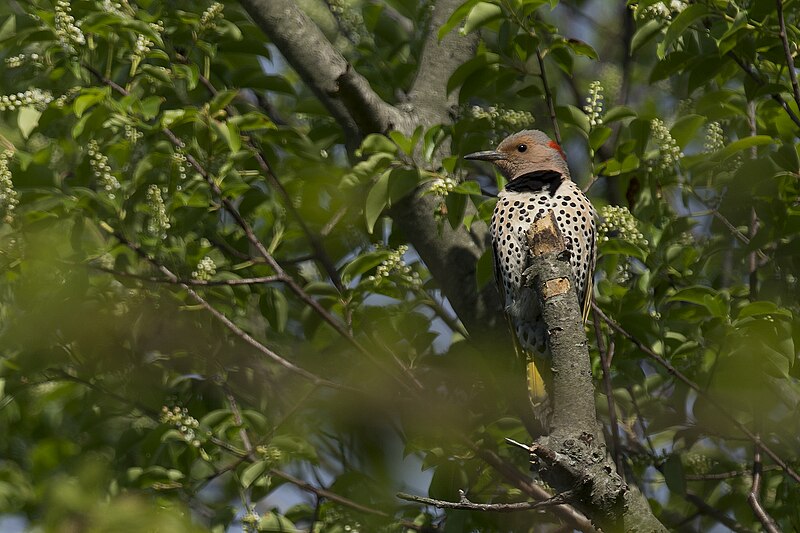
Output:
464,130,569,181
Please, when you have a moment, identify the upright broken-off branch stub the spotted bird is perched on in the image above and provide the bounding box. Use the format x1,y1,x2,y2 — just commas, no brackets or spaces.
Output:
524,211,666,532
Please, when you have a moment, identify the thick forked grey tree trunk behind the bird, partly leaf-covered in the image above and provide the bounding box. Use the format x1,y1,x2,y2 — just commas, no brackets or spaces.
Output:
241,0,501,334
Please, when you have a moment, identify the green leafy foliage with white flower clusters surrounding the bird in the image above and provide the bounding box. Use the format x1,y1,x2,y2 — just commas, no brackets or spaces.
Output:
0,0,800,532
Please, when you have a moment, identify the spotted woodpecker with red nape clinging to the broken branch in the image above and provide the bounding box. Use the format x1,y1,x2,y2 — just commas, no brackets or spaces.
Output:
465,130,595,412
